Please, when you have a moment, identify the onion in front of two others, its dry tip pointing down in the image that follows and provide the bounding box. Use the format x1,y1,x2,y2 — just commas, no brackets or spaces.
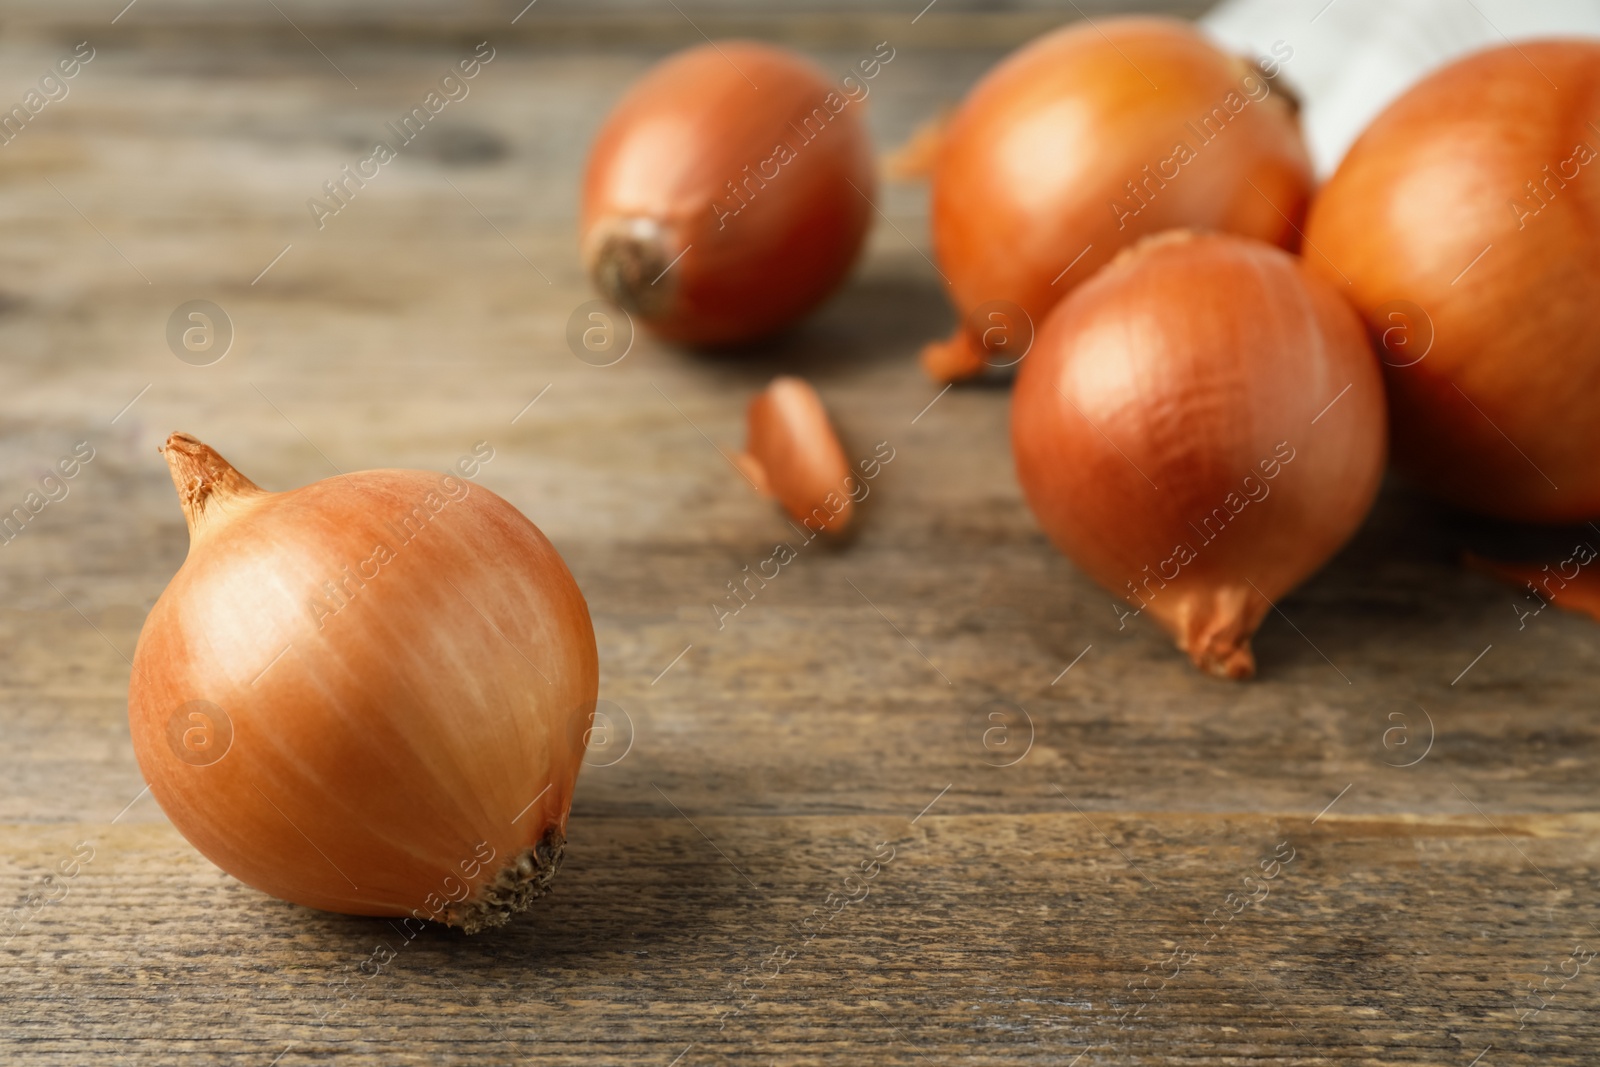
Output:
1011,232,1386,678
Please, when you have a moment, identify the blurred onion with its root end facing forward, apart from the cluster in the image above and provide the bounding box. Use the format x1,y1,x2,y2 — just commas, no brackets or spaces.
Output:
581,42,875,346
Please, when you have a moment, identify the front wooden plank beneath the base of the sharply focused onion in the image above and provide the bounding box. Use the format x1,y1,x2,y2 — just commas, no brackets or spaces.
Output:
0,812,1600,1064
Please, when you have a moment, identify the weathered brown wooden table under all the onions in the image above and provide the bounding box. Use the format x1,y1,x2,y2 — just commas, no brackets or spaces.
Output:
0,0,1600,1067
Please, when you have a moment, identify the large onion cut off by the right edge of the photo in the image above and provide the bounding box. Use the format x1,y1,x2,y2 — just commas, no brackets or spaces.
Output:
1306,40,1600,523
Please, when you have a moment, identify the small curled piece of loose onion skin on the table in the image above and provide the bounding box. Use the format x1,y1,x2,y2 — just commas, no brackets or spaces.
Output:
738,376,854,534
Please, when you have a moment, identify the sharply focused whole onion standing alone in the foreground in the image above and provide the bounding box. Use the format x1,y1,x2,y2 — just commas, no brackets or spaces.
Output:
128,434,598,933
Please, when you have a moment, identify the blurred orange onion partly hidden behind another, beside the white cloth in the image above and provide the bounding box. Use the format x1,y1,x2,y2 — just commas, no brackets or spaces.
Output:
923,18,1310,381
